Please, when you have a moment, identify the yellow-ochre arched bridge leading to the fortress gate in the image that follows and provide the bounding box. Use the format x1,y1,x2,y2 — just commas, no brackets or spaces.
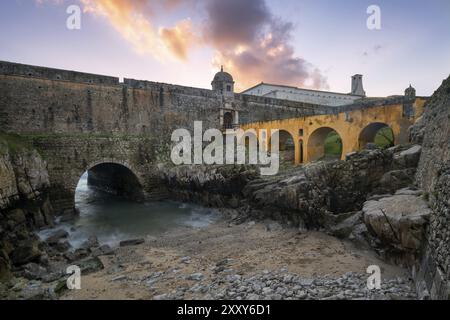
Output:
241,97,426,164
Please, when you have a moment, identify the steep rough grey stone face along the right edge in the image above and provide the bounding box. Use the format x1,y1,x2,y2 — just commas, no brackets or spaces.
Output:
412,77,450,299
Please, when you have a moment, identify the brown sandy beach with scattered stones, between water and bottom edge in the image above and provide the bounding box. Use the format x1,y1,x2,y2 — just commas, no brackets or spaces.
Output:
61,220,417,300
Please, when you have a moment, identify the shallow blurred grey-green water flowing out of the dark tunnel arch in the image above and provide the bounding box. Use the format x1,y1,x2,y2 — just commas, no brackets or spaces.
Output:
40,174,219,248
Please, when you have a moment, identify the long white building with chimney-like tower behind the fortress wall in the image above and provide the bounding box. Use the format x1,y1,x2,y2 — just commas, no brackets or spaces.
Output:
242,74,366,107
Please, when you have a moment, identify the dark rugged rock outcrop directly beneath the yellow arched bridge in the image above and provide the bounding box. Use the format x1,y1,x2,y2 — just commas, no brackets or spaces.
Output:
161,145,421,229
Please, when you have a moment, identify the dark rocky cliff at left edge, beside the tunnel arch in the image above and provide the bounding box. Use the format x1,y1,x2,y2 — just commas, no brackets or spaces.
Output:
0,137,53,280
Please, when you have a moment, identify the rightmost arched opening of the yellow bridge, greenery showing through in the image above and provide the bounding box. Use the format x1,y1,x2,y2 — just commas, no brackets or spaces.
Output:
359,122,395,150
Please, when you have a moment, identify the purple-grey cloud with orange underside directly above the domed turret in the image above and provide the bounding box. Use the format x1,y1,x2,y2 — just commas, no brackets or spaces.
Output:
204,0,328,90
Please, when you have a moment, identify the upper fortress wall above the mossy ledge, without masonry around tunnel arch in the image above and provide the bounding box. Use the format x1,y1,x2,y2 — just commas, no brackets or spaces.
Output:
0,62,331,136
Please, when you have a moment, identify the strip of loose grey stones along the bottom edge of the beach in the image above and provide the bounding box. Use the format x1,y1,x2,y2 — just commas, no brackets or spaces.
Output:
149,269,416,300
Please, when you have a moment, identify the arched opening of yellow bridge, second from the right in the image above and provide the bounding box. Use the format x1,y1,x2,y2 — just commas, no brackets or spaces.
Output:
308,127,342,161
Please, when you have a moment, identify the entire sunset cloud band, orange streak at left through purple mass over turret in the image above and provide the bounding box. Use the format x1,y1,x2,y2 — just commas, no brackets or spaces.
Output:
35,0,328,90
